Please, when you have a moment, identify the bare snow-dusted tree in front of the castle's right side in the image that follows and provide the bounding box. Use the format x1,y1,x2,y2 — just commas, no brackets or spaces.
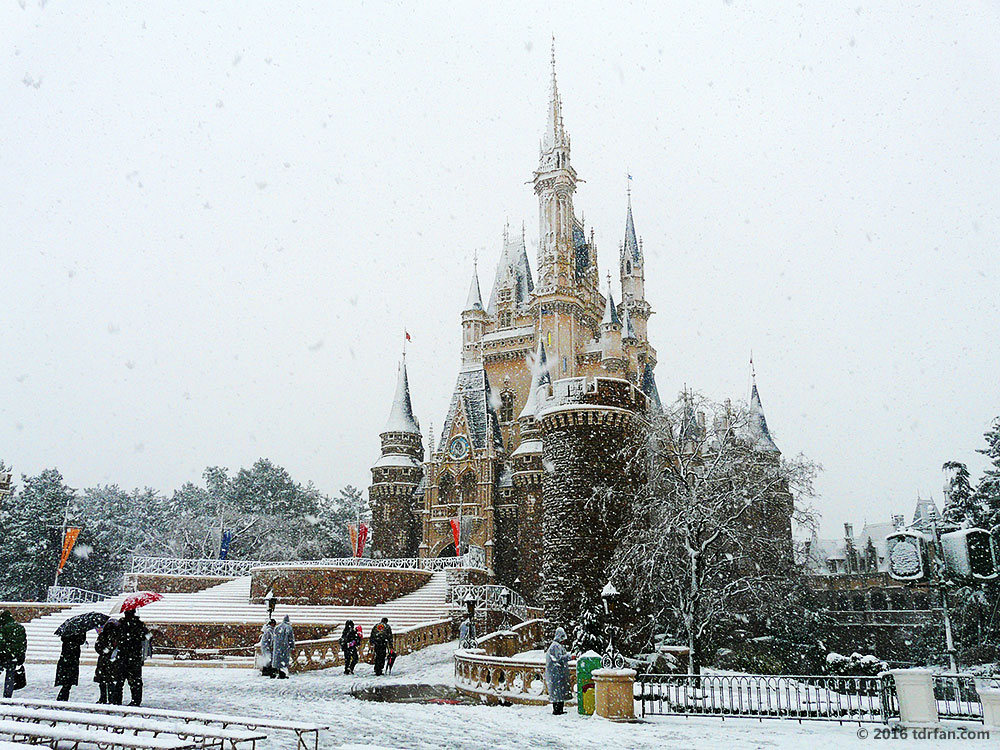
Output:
613,393,817,674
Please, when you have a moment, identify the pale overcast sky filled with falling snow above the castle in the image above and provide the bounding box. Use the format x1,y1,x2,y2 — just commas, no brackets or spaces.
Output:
0,0,1000,532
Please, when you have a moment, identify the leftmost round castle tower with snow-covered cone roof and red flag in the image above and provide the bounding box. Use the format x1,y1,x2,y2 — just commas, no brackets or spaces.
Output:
368,360,424,557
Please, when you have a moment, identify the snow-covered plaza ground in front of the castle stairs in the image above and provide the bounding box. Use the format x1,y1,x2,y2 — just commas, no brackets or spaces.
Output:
11,643,996,750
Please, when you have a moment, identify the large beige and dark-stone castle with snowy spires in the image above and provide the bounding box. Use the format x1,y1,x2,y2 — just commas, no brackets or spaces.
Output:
369,44,780,621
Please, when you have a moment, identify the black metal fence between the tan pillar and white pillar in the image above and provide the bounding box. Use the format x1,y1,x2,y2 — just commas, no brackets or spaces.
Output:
635,674,899,723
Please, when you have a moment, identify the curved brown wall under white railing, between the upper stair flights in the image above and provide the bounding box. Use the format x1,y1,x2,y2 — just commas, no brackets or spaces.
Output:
250,565,431,607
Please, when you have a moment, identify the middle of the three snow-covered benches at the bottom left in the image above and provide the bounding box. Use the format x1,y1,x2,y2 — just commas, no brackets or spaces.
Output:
0,704,267,750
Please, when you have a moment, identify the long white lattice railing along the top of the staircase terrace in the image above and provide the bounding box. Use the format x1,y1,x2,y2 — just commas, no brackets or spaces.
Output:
131,547,486,578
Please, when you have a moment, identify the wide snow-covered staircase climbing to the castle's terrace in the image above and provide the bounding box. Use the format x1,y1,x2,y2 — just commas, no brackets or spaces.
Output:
24,571,454,667
